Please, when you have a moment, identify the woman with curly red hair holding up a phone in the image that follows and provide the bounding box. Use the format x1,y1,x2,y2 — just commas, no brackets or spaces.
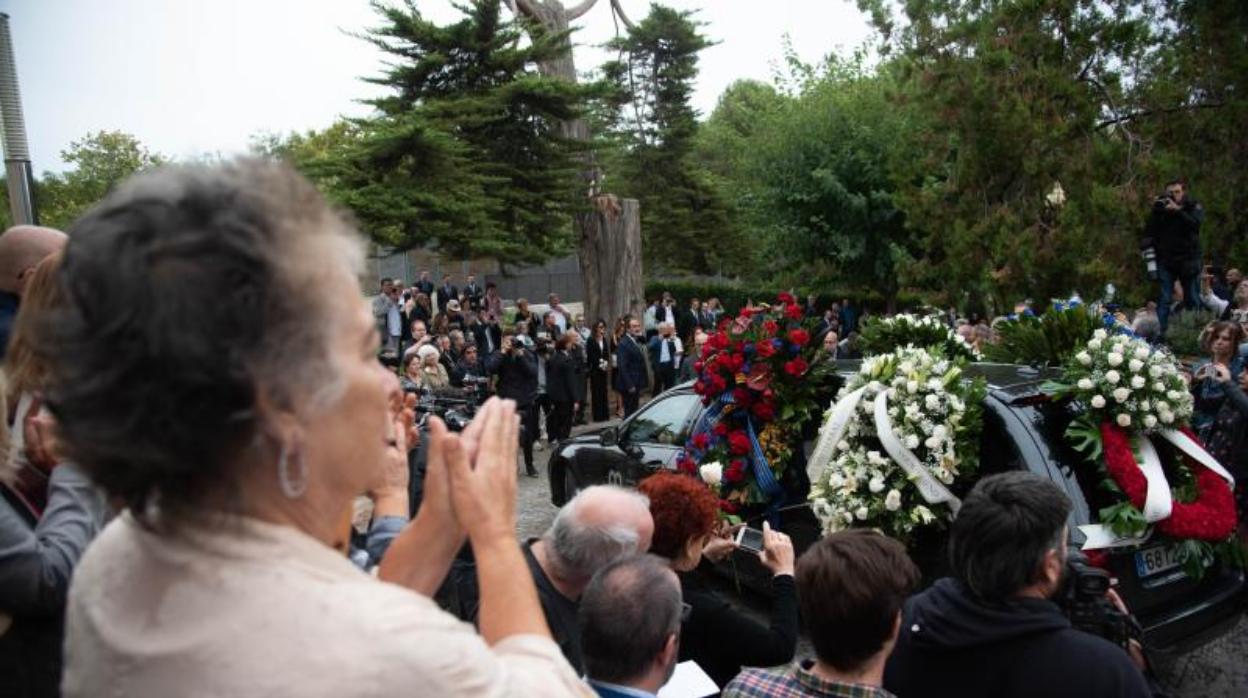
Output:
638,472,797,687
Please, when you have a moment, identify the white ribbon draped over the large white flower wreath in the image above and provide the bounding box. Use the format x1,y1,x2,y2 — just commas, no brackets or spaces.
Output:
806,386,962,513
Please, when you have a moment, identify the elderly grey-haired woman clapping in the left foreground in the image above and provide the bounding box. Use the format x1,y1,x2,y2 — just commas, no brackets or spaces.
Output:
44,161,585,697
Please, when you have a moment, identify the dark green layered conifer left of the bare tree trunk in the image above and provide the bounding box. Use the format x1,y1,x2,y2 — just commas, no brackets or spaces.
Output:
316,0,593,262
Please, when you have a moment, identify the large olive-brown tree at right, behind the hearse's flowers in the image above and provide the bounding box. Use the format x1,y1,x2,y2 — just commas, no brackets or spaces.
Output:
860,0,1153,307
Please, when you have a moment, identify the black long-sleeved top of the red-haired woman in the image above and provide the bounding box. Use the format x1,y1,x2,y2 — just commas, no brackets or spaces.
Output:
679,566,797,688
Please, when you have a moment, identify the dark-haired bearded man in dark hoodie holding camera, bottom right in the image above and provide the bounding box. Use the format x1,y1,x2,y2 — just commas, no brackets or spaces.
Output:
884,472,1151,698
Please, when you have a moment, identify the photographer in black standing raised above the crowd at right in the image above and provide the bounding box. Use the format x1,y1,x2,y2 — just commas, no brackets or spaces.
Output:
1139,180,1204,337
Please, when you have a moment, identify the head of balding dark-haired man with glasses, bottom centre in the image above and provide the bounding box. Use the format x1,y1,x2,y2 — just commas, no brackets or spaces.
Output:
578,554,685,698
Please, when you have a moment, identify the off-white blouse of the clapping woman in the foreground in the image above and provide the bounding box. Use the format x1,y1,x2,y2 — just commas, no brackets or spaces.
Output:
62,512,593,698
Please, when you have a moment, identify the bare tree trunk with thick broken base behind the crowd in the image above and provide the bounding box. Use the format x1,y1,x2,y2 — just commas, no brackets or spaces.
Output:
509,0,645,327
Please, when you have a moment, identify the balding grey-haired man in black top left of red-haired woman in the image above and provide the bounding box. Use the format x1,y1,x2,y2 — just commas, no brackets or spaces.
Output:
523,484,654,676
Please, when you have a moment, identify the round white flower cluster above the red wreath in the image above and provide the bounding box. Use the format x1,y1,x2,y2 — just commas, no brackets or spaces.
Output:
1047,330,1192,432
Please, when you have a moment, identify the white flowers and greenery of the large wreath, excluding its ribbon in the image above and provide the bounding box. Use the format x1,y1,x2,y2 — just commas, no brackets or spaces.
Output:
810,346,985,539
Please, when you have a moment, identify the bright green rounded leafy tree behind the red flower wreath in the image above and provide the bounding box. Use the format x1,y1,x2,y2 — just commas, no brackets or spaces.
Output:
743,54,915,306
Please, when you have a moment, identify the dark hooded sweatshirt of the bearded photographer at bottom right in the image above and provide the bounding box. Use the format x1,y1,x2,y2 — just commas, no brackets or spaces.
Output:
884,577,1152,698
